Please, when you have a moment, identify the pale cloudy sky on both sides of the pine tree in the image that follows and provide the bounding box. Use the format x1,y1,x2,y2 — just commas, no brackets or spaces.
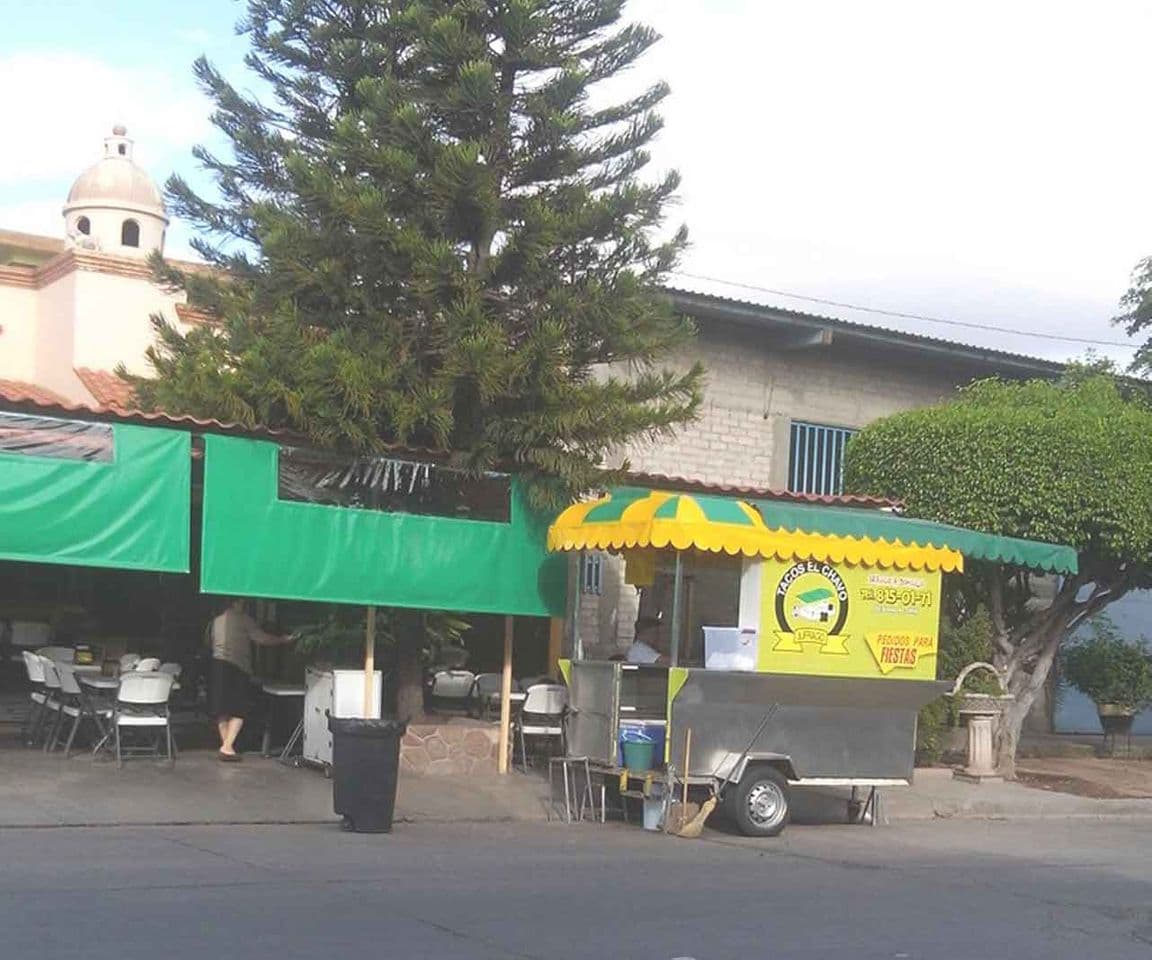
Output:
0,0,1152,362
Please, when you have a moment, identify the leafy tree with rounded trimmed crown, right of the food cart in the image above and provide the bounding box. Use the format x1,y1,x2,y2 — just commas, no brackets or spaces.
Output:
846,371,1152,774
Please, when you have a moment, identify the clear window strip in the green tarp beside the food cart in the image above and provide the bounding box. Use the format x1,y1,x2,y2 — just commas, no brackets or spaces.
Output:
278,447,511,523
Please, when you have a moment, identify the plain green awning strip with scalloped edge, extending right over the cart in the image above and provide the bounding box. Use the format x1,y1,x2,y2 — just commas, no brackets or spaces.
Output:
753,500,1078,574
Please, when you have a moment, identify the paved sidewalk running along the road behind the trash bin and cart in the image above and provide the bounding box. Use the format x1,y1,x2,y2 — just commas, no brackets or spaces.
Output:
0,738,1152,827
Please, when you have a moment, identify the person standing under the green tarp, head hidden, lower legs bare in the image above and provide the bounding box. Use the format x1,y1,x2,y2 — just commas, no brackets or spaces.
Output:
209,599,290,763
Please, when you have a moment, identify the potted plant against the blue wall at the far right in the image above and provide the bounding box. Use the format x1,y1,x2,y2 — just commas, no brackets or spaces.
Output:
1062,615,1152,736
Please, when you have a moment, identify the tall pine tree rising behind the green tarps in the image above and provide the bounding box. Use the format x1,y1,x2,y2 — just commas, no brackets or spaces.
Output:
134,0,702,497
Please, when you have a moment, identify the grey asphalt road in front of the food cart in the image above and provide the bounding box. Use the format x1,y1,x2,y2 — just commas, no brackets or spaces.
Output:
0,821,1152,960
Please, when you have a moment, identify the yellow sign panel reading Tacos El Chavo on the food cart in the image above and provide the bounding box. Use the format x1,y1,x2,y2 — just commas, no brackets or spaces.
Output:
757,560,940,680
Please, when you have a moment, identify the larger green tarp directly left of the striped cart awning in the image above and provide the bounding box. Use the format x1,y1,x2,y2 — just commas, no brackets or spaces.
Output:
200,437,567,617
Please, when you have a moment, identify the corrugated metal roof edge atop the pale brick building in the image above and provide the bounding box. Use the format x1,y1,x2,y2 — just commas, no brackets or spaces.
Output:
666,287,1067,377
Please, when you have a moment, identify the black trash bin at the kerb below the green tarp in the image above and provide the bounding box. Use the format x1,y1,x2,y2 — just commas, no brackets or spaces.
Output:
328,716,408,833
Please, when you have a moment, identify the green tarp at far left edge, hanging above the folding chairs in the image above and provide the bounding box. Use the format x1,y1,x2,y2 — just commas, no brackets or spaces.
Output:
0,424,191,573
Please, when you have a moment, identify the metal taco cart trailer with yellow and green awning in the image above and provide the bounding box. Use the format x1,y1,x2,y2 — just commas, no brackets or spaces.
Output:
548,490,1076,836
